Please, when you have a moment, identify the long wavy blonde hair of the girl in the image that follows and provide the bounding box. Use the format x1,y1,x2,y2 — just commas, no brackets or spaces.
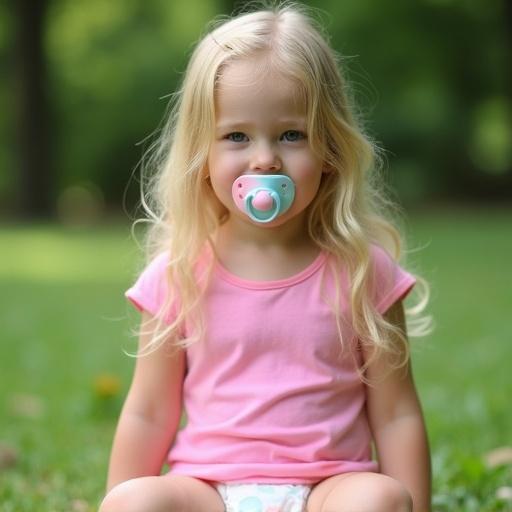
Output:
134,3,428,372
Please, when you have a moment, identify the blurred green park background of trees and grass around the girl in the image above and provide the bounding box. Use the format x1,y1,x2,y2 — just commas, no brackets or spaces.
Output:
0,0,512,512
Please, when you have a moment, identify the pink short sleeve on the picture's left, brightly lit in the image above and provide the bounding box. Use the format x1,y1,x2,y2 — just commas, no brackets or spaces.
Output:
125,252,175,322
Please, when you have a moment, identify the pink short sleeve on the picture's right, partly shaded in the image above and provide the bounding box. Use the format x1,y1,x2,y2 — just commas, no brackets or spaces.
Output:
372,245,416,314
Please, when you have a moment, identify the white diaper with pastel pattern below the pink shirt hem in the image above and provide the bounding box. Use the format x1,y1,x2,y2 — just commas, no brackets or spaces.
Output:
215,483,311,512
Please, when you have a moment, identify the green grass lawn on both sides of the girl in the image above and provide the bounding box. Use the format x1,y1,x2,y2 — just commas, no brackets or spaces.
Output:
0,211,512,512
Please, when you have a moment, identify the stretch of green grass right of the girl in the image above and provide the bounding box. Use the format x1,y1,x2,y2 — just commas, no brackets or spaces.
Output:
404,210,512,512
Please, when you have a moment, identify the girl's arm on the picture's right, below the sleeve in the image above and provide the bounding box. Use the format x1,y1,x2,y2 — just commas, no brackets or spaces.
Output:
367,301,431,512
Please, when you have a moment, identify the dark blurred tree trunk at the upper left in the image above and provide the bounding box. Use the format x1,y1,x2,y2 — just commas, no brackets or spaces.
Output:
13,0,54,219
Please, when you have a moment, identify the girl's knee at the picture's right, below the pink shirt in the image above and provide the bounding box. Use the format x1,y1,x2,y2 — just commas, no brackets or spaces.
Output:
307,473,412,512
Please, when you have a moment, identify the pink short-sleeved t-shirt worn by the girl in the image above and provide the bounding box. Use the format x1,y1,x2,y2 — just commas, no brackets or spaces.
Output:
126,247,415,483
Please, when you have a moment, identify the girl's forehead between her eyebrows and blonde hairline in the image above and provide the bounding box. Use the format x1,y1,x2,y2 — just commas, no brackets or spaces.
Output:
215,57,306,117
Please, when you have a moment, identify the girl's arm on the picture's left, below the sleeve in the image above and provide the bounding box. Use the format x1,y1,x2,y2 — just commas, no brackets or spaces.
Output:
107,313,185,490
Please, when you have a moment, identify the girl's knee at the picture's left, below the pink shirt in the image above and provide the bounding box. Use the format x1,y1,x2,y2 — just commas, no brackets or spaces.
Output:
99,475,224,512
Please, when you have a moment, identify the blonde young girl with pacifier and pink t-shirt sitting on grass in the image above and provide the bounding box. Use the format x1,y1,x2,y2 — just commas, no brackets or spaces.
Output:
100,5,430,512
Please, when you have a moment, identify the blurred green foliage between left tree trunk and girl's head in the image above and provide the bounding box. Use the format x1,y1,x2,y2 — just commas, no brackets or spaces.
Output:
48,0,219,208
